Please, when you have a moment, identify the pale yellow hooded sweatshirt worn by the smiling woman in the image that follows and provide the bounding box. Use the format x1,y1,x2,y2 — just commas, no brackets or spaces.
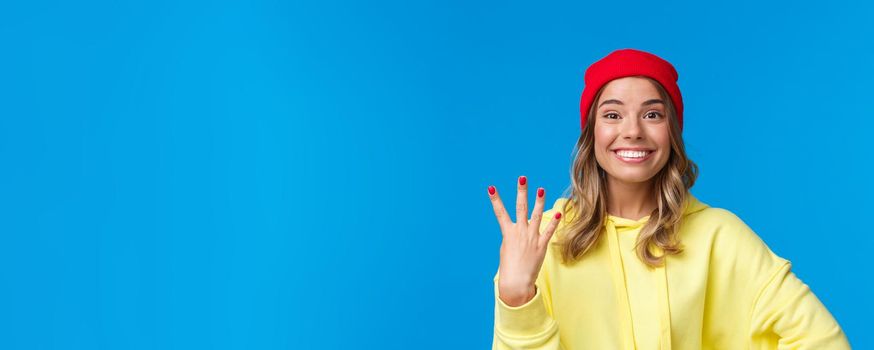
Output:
492,194,850,350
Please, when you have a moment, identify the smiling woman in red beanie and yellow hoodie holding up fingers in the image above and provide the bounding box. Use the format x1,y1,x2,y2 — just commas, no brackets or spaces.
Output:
488,49,849,349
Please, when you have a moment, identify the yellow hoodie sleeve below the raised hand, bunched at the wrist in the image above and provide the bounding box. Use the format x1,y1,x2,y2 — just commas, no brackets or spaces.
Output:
492,205,561,350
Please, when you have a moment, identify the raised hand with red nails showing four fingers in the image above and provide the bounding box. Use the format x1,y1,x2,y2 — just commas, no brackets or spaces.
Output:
489,176,561,306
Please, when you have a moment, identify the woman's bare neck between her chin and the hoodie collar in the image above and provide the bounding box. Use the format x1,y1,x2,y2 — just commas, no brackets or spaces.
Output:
607,176,658,220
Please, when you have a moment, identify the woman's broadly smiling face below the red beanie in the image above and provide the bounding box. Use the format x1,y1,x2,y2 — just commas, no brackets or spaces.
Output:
594,77,671,183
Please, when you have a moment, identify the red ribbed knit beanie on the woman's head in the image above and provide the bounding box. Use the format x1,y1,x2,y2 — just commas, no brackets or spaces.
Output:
580,49,683,131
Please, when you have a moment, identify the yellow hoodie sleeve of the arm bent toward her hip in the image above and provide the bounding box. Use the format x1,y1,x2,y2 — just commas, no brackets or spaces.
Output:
751,261,850,349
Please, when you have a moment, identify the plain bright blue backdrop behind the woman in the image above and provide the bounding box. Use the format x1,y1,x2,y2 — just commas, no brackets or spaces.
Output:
0,1,874,349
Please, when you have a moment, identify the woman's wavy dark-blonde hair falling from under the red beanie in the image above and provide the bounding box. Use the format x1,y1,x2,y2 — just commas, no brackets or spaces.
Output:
555,76,698,267
